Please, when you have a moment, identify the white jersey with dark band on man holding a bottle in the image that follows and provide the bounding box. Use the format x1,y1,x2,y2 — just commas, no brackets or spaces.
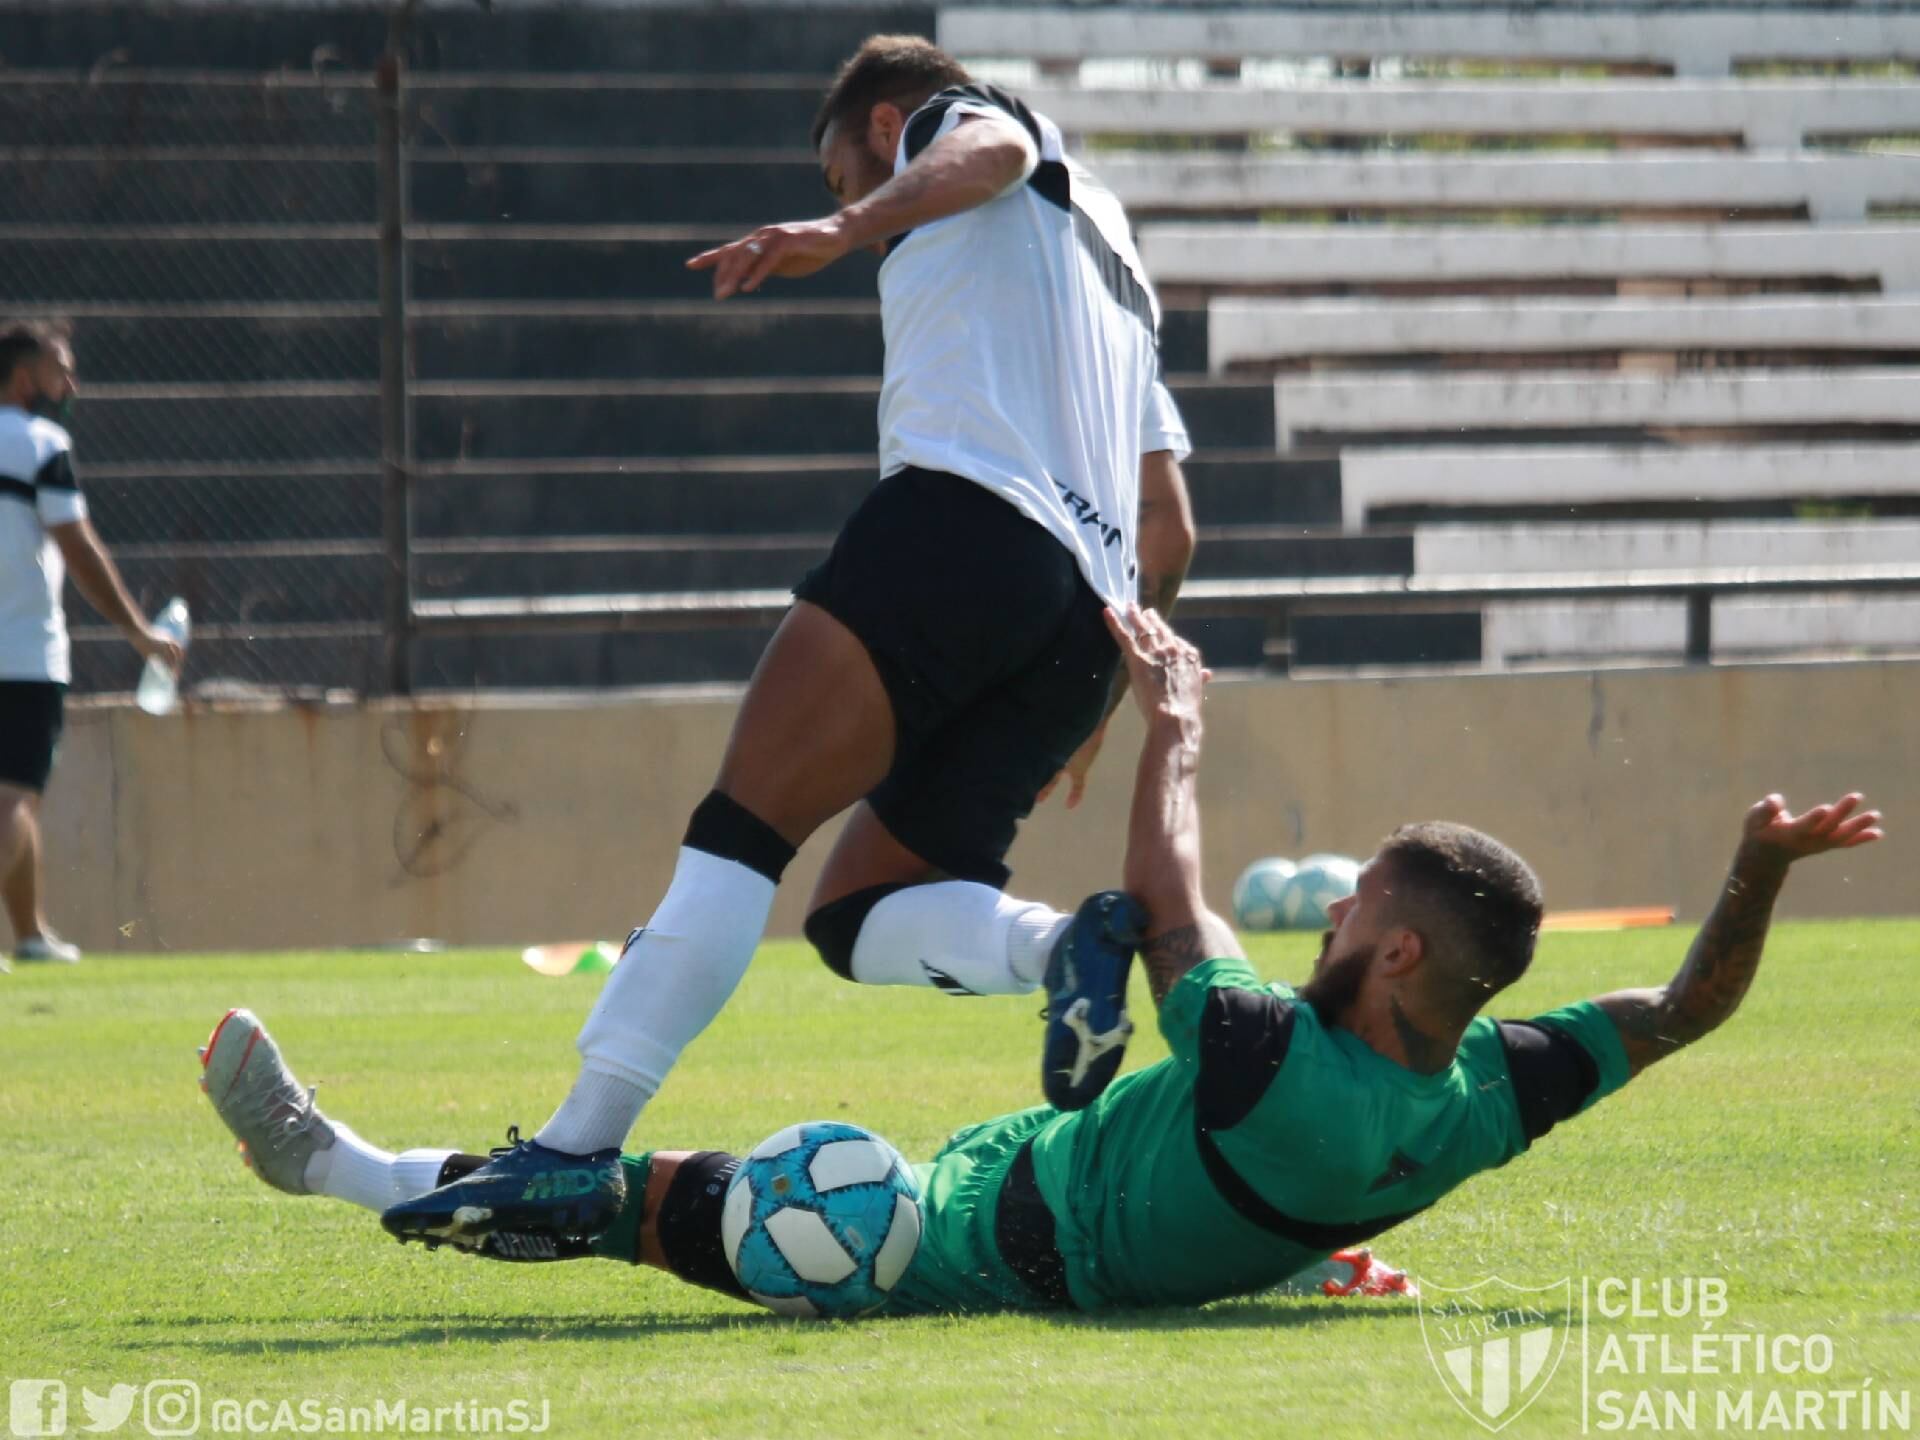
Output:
0,405,86,685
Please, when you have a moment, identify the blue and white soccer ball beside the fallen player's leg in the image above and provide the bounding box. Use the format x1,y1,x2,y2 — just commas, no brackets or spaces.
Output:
720,1119,920,1319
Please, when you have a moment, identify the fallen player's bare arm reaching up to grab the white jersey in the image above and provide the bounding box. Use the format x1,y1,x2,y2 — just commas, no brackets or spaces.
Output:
1106,607,1240,1004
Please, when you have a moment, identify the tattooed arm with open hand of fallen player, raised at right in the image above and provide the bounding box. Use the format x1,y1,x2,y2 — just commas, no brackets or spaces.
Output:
1597,795,1882,1075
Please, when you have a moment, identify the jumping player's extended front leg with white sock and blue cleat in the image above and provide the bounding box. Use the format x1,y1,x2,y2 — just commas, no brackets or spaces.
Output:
386,601,895,1240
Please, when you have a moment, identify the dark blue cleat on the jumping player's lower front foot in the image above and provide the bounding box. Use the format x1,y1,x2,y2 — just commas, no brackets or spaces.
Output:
380,1131,626,1260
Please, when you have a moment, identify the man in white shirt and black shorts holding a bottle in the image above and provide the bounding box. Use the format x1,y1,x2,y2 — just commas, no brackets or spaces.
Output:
0,324,180,970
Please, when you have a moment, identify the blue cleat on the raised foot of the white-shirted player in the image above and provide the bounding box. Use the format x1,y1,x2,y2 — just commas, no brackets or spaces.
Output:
1041,891,1146,1110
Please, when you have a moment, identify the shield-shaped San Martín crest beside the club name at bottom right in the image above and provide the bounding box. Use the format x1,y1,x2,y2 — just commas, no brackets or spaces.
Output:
1419,1275,1572,1432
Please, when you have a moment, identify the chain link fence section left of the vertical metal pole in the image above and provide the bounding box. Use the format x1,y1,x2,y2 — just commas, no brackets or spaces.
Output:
0,67,390,695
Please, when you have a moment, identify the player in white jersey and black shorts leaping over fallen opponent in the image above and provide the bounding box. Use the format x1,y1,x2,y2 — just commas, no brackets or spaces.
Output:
388,36,1192,1238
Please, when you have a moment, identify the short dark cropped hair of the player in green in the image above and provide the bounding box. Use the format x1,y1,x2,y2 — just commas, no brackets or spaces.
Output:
1379,820,1544,1018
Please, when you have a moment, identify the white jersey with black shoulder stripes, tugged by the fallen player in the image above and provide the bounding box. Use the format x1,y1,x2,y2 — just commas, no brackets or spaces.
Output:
879,84,1190,605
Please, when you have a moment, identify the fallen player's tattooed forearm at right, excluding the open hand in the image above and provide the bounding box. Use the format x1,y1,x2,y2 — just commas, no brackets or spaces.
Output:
1601,847,1788,1073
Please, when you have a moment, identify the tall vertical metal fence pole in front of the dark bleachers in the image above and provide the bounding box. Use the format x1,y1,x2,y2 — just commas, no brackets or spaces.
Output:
374,24,413,695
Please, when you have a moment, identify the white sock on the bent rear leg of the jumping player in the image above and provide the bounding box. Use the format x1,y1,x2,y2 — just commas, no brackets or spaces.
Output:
852,879,1073,995
